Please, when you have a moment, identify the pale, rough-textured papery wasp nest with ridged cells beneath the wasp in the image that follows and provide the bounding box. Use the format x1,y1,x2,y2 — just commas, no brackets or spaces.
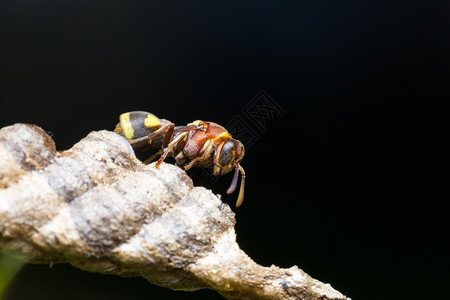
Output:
0,124,348,299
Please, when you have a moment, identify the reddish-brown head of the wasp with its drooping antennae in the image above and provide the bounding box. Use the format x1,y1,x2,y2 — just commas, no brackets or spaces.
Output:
213,139,245,207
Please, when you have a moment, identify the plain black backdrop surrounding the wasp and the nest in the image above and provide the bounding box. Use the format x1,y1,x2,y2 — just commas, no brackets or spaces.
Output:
0,0,450,299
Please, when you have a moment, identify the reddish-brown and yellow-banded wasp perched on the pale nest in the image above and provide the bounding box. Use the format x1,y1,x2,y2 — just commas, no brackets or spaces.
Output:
114,111,245,207
